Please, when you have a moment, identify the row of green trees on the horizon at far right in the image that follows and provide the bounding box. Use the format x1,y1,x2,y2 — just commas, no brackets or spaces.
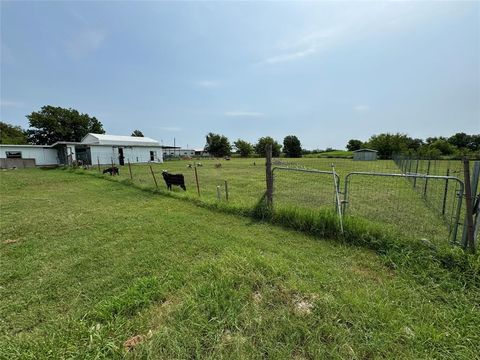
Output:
346,132,480,159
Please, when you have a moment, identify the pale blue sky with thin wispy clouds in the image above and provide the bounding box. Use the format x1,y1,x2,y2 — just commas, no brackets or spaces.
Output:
0,1,480,149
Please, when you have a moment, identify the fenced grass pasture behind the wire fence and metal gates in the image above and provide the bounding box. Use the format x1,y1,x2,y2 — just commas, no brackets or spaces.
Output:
91,154,478,250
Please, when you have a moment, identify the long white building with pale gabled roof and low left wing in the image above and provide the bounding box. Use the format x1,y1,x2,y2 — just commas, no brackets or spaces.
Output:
0,133,163,167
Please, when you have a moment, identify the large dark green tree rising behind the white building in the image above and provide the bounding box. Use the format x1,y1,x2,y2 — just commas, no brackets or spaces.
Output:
27,105,105,145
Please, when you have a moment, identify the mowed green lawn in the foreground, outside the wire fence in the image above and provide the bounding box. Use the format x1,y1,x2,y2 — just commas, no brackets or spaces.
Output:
0,169,480,359
